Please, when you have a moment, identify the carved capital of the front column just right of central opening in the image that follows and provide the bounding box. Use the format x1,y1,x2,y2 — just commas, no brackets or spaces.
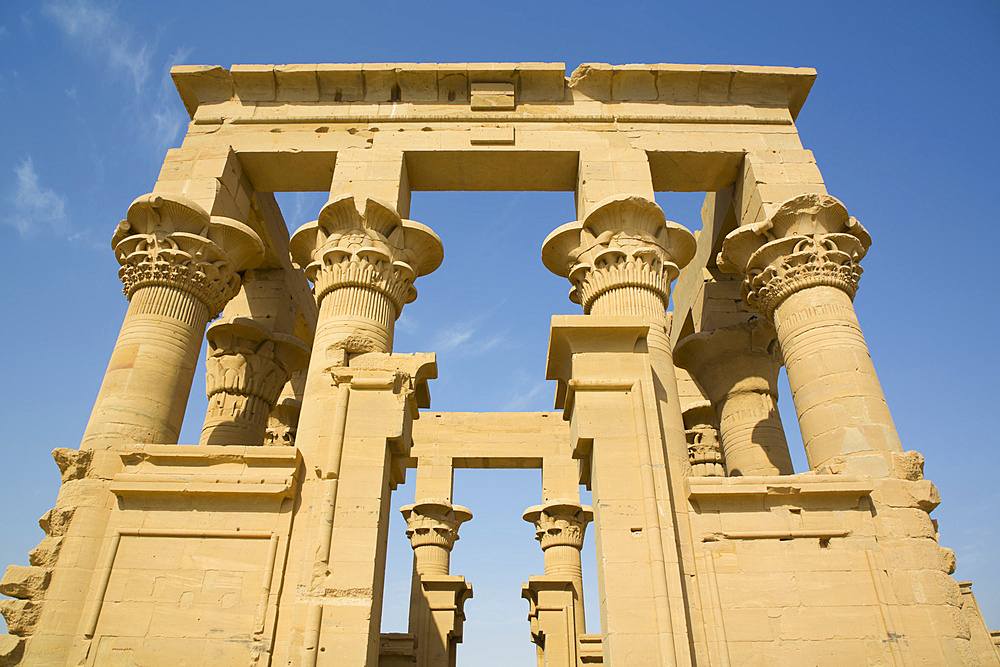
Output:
542,195,695,315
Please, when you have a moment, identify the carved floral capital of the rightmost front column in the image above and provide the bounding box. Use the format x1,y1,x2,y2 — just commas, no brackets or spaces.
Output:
718,194,871,319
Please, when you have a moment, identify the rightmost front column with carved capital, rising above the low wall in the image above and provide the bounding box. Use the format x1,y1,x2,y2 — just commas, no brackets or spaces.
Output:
719,194,902,475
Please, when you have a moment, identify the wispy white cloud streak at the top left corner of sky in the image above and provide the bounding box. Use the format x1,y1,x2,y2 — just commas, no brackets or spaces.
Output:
42,0,152,94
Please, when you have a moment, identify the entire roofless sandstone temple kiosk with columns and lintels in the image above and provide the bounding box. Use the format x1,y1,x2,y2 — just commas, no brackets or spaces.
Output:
0,63,1000,667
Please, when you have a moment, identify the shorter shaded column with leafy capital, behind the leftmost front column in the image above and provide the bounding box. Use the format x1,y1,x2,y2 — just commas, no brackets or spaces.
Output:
201,317,309,445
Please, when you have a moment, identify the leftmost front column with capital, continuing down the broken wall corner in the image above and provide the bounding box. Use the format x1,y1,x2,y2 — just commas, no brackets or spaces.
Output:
20,194,264,664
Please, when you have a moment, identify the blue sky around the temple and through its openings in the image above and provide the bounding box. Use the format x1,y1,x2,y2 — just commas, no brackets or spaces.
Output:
0,0,1000,665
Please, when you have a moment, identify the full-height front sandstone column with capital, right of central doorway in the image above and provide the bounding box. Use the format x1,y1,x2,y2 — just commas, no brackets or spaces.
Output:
542,194,695,664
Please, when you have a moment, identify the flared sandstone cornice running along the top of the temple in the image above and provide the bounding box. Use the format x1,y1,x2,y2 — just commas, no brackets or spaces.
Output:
171,63,816,123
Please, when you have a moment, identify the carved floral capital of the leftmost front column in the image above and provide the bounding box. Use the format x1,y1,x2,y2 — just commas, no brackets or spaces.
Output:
111,195,264,318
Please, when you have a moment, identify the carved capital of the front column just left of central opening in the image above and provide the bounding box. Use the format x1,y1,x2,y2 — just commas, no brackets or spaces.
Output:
289,195,444,319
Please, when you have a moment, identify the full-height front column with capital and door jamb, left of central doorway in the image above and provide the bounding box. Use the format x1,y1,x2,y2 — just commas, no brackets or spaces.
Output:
289,190,443,664
